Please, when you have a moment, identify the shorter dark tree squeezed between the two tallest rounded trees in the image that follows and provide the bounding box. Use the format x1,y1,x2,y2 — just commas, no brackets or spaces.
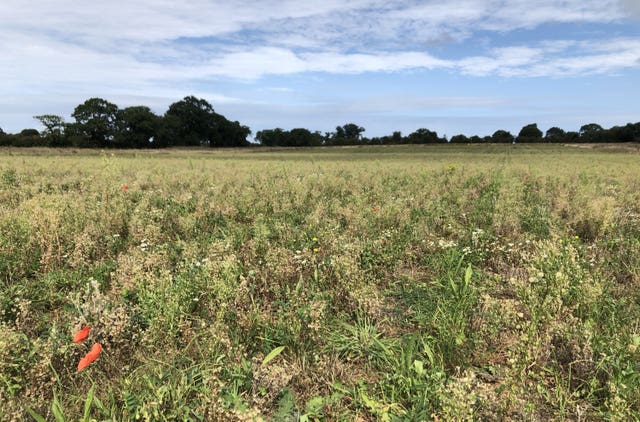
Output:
114,106,160,148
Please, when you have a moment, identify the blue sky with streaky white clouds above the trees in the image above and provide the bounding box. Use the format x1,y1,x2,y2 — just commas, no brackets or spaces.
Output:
0,0,640,137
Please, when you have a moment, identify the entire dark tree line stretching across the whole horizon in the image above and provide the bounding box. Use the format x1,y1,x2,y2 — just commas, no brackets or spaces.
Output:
0,96,640,148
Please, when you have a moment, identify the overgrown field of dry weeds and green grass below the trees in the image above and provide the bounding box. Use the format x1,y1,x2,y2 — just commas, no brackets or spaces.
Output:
0,145,640,421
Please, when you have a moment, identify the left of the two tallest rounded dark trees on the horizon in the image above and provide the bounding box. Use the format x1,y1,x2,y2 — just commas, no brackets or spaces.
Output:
70,98,118,147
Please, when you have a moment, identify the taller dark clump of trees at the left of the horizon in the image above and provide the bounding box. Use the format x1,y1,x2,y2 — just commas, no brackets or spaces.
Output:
0,96,251,148
